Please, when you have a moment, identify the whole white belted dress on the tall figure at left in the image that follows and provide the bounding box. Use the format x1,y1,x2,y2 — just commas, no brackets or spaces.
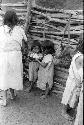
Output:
0,25,27,90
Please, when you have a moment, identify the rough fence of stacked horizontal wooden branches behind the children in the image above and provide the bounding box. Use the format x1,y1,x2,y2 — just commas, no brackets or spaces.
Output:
2,3,83,93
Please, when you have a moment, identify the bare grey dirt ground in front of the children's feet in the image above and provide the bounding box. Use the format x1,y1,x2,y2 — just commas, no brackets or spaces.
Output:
0,86,73,125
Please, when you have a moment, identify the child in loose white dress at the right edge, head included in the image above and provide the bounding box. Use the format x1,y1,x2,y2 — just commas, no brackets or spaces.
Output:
61,40,83,120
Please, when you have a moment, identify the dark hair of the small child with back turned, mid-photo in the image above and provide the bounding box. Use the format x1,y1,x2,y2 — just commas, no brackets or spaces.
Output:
42,40,55,54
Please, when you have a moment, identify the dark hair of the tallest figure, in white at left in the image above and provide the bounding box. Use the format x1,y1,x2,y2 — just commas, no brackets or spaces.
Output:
3,10,18,27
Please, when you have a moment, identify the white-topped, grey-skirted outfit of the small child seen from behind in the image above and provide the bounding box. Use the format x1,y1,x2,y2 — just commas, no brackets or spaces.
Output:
37,54,54,90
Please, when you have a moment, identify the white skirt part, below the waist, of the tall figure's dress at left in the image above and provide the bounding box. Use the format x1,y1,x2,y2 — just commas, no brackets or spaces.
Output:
0,51,23,90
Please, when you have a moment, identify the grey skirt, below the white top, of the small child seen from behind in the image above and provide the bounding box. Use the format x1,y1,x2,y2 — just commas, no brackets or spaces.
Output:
37,63,54,90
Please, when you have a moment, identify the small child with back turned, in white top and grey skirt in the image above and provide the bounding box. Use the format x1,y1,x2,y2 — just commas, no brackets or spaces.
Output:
37,40,55,98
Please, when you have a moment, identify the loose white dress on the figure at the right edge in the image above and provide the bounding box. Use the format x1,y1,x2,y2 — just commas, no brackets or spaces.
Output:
61,52,83,108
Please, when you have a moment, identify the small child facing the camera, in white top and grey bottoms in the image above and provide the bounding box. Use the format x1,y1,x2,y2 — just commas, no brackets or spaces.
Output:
28,40,42,92
